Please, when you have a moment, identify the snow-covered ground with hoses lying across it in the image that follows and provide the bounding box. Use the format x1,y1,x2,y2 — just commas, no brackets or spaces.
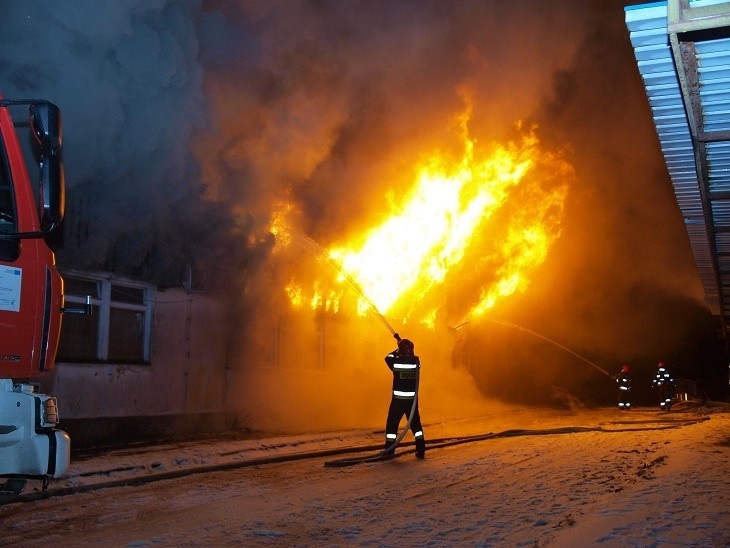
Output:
0,400,730,546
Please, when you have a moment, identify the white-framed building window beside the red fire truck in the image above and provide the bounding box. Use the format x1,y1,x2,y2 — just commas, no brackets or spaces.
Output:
58,272,154,364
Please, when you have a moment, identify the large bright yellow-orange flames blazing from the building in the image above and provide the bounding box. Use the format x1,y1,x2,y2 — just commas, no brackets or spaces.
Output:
272,104,571,326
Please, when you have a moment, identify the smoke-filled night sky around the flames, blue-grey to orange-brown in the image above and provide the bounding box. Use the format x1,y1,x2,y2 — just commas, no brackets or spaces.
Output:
0,0,716,402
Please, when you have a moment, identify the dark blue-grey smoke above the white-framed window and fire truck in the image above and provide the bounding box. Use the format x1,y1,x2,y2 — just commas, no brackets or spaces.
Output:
0,0,246,285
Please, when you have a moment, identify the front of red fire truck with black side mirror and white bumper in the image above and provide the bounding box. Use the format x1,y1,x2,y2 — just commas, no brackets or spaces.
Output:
0,97,70,493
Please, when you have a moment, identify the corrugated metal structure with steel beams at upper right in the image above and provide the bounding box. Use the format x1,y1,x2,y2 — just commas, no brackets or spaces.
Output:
625,0,730,336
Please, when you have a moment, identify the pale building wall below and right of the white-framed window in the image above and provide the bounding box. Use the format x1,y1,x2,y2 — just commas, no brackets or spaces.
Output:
41,289,227,444
